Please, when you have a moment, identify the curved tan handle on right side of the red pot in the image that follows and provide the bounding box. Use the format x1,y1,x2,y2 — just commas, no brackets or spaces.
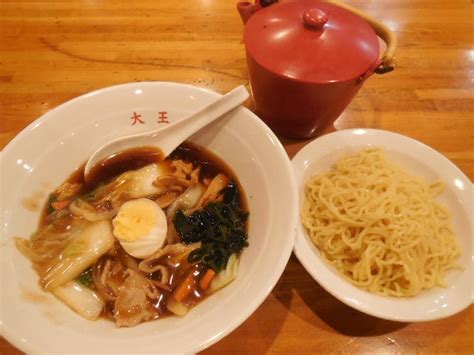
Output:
326,0,397,74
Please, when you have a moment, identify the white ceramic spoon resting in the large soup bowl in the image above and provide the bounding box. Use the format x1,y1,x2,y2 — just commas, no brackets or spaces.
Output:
84,85,249,179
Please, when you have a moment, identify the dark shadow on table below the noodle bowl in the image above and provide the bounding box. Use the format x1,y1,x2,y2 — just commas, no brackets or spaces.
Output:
272,254,408,336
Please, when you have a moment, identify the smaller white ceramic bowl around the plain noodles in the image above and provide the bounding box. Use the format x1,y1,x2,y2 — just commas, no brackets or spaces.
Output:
292,129,474,322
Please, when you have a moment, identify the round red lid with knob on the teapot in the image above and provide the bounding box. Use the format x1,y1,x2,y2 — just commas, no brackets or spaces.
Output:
244,0,379,83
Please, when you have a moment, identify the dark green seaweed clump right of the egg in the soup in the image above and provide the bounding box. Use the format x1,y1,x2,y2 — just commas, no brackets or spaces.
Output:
174,182,248,272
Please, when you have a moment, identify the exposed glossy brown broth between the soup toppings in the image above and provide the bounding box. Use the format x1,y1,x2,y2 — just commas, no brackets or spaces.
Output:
32,142,248,326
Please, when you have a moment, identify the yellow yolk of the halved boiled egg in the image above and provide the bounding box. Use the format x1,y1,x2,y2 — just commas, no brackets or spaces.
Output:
112,200,157,242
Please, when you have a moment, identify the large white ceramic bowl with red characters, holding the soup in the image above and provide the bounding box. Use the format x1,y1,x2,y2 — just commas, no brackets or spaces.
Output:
0,82,297,353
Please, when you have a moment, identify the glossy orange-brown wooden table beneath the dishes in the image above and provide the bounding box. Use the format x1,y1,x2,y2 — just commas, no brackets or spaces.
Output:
0,0,474,354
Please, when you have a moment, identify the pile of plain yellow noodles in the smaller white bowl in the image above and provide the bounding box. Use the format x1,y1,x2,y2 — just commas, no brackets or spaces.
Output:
301,149,460,297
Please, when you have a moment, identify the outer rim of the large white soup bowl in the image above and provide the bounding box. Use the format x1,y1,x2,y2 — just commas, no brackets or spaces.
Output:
0,81,298,352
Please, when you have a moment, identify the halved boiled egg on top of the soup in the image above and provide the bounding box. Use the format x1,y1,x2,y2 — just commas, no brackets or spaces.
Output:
112,198,168,259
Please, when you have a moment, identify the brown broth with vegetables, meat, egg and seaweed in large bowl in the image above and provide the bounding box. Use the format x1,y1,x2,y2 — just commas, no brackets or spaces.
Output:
16,143,248,327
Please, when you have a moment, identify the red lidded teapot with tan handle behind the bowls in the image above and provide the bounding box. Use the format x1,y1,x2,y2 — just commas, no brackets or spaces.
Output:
237,0,397,138
